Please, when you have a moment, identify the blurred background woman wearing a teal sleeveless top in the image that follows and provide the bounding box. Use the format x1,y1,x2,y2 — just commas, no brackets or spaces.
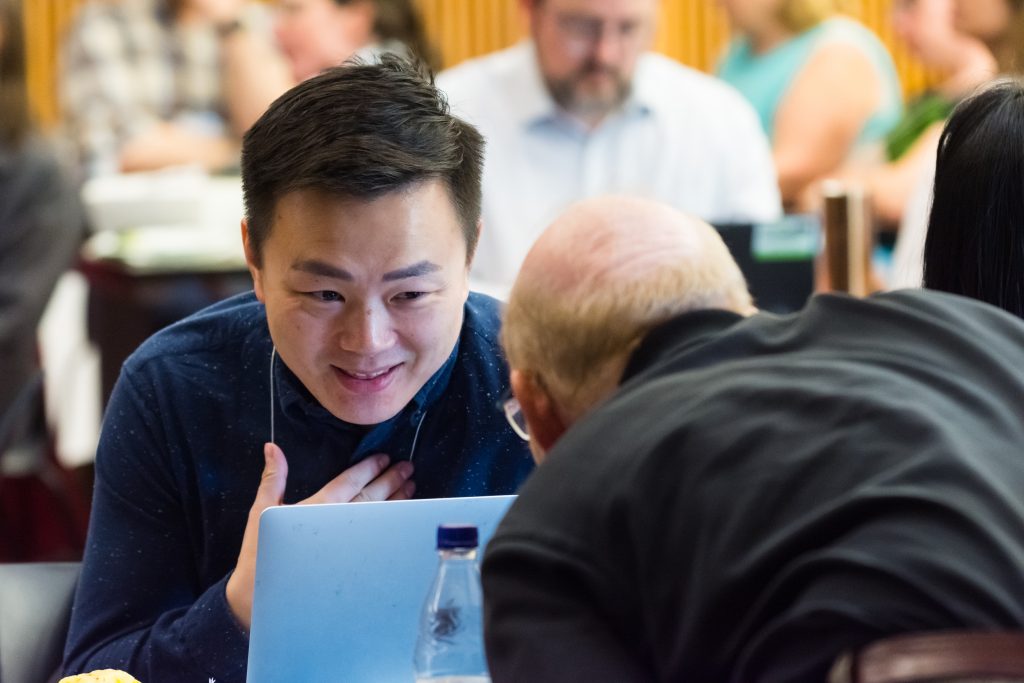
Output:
718,0,903,210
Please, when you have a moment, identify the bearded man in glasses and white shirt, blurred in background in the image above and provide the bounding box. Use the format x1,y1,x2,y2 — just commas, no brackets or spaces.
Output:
437,0,780,293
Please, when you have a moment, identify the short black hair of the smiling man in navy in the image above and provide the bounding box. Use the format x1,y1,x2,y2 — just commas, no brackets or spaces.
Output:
242,55,483,265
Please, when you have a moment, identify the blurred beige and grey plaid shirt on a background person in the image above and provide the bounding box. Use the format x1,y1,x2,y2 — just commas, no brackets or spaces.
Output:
59,0,266,176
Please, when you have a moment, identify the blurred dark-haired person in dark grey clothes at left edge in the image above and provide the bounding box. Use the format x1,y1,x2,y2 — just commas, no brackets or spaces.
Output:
0,0,85,444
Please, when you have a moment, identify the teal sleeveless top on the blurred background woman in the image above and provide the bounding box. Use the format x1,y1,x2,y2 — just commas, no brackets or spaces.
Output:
718,17,903,146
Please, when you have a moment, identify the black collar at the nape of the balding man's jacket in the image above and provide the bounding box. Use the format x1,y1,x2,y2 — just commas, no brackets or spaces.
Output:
620,309,743,384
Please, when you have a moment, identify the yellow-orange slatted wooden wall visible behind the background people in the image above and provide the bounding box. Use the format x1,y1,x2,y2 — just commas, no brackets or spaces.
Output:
23,0,932,123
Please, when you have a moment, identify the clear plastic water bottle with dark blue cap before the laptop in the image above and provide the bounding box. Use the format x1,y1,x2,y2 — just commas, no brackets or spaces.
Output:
413,524,490,683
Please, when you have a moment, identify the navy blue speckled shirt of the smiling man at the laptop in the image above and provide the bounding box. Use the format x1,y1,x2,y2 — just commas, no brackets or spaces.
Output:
66,293,532,683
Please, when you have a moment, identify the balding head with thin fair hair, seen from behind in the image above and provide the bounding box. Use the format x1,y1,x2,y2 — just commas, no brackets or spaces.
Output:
502,197,753,458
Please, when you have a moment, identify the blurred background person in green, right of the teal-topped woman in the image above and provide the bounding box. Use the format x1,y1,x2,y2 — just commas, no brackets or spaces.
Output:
827,0,997,226
